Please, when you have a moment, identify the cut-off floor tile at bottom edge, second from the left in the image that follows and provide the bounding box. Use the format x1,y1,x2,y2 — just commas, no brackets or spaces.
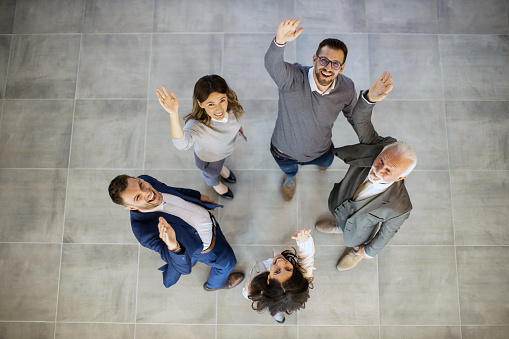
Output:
55,323,134,339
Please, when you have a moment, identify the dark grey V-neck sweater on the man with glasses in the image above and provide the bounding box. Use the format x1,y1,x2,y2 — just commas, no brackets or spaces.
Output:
265,40,357,162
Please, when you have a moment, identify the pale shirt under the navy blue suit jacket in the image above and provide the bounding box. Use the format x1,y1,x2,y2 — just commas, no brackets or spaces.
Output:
140,193,213,250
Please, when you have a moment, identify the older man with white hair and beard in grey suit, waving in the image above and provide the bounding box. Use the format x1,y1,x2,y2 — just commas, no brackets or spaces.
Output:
315,72,417,271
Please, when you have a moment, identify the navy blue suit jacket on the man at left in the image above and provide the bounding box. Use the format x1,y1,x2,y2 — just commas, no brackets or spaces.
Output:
131,175,222,287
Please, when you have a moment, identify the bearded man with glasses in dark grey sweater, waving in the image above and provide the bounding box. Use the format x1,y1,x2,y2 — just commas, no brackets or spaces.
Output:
265,19,357,201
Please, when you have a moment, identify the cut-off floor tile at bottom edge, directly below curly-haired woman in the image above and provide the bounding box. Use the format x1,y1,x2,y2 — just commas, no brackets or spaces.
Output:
217,323,297,339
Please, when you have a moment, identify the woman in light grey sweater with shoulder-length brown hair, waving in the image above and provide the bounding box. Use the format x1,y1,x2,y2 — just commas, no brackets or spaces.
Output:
157,74,244,199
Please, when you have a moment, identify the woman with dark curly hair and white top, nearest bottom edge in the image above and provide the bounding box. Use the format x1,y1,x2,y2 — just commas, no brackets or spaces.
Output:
242,229,315,324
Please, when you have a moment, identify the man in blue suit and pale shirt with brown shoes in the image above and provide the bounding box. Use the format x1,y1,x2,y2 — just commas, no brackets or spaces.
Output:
108,174,244,291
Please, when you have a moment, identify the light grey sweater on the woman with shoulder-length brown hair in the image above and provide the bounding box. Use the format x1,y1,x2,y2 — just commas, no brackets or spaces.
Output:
173,113,240,162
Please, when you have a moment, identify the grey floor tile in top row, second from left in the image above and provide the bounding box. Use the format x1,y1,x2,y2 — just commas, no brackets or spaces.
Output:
14,0,86,34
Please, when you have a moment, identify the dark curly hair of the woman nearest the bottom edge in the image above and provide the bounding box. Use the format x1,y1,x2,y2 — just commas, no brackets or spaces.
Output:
248,249,312,316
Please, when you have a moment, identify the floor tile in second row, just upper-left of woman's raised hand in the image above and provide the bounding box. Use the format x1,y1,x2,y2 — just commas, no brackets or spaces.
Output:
77,34,150,98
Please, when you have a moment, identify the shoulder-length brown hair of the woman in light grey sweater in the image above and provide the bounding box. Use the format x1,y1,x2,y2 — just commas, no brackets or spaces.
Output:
184,74,244,126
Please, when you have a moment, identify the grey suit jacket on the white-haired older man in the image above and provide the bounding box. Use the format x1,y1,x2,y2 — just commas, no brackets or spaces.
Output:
329,93,412,257
